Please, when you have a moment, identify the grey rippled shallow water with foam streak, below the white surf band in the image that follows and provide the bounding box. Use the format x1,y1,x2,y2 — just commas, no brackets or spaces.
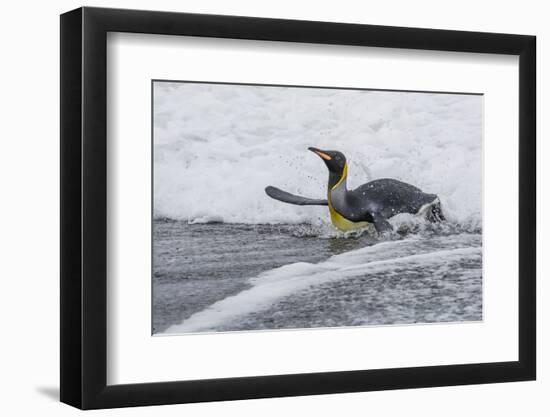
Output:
153,220,482,333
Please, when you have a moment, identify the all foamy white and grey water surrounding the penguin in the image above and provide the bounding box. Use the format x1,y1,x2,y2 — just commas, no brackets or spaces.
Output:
153,82,483,333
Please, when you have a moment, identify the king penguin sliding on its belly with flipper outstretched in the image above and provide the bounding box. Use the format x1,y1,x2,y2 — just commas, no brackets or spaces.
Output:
265,148,445,234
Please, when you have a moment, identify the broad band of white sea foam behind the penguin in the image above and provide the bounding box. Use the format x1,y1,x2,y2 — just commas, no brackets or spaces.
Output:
154,82,483,225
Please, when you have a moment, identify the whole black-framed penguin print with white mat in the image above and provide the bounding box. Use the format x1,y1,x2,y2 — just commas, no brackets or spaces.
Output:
61,7,536,409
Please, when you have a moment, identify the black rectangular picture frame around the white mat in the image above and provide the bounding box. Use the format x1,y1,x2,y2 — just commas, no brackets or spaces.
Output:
60,7,536,409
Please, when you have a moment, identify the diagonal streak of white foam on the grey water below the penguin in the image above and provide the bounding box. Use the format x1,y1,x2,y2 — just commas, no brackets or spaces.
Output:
165,234,482,333
